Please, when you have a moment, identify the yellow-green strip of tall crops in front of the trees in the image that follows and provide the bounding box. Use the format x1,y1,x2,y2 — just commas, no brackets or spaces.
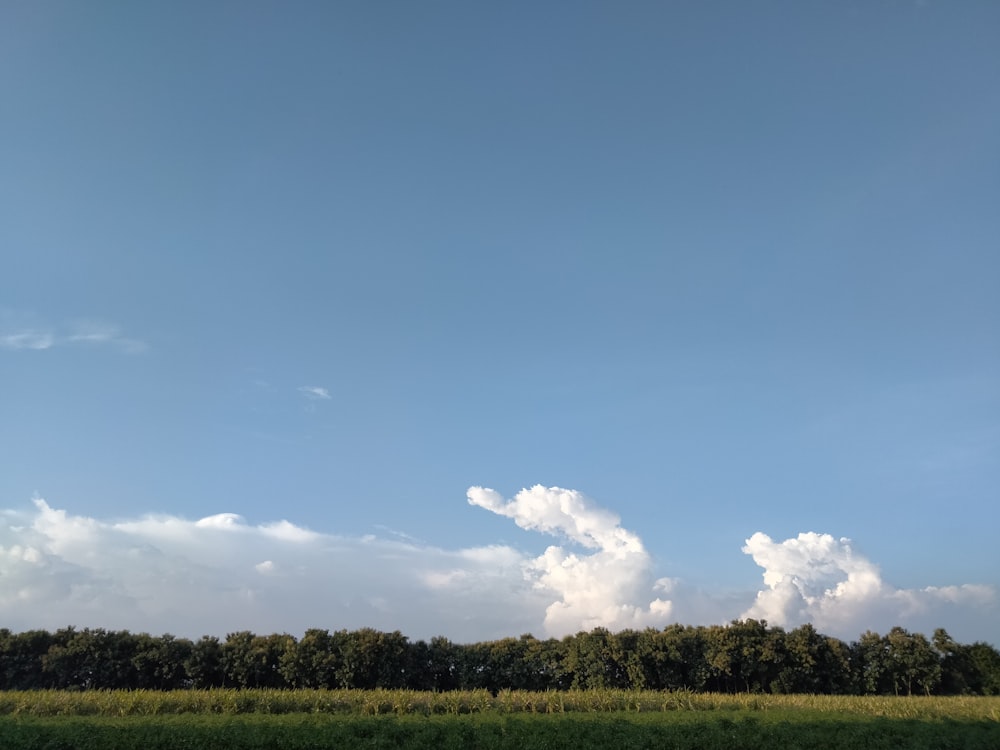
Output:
0,689,1000,724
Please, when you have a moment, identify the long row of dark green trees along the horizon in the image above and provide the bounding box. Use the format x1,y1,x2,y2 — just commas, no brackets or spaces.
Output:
0,619,1000,695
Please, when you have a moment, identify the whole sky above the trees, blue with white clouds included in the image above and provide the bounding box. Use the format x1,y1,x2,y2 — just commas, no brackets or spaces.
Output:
0,1,1000,643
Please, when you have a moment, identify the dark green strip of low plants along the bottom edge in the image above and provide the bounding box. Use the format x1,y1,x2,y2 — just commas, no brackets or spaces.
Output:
0,710,1000,750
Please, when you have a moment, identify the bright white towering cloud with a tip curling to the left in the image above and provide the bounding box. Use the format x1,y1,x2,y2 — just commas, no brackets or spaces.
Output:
468,485,671,635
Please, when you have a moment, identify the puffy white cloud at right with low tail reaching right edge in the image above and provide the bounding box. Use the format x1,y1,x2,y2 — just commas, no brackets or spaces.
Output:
743,532,997,635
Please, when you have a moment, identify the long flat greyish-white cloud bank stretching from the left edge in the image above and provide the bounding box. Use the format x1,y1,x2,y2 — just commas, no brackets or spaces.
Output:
0,500,547,641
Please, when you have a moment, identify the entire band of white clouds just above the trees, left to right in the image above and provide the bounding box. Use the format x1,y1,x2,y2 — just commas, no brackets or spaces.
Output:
0,485,998,642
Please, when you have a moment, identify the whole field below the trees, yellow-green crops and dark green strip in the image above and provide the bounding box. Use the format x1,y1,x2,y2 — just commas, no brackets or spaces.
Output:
0,690,1000,750
